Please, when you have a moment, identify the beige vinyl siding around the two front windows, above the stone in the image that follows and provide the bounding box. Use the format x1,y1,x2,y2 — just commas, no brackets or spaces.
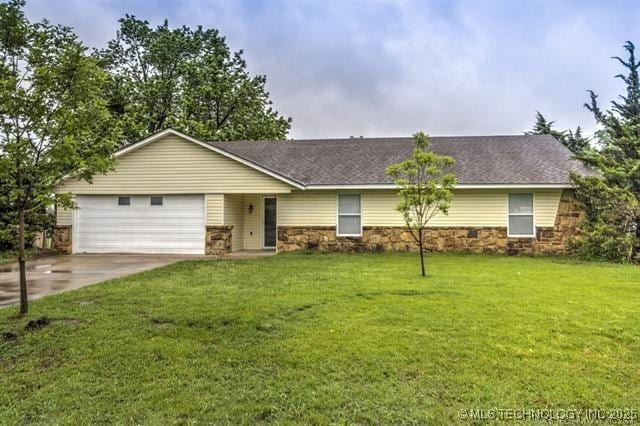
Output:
278,189,562,227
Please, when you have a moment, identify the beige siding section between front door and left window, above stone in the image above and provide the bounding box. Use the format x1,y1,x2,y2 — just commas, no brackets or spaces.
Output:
278,191,336,226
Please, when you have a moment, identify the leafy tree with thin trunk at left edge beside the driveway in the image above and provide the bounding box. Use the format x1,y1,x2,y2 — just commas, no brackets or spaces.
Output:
0,0,117,314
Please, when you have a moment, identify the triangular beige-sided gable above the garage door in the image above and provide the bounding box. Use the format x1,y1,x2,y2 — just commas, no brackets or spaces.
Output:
57,136,292,195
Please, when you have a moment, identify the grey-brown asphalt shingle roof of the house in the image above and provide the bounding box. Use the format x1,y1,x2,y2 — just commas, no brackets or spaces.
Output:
209,135,594,185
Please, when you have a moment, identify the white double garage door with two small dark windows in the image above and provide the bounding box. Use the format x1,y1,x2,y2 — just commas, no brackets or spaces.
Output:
73,195,205,254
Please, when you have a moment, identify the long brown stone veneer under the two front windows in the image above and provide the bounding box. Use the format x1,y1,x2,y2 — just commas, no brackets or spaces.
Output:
278,190,583,254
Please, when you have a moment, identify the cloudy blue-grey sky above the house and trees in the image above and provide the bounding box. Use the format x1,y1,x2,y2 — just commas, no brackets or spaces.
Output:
26,0,640,138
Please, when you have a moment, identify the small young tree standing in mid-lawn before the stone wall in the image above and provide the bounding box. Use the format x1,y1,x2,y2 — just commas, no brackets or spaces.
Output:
387,132,456,276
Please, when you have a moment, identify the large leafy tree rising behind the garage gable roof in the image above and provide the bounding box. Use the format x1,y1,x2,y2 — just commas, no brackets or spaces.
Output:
96,15,291,142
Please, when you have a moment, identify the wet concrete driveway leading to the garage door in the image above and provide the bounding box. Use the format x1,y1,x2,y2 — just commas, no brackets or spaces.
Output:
0,254,199,306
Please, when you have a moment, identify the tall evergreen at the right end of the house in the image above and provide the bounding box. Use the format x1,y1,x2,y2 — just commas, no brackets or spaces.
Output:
573,42,640,262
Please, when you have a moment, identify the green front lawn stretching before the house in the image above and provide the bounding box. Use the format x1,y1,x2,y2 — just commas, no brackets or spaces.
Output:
0,253,640,424
